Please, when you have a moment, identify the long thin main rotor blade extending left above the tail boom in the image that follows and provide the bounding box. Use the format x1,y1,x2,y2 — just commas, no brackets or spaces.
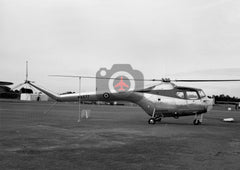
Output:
49,75,163,81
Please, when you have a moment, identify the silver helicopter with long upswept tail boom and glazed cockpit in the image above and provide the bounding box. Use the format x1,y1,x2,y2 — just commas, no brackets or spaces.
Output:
25,76,240,125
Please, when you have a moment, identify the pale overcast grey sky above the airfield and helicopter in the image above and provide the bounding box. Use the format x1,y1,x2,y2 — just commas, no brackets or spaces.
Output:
0,0,240,97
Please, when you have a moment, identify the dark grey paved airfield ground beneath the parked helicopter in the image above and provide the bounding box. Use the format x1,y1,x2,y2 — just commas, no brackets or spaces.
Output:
0,101,240,170
